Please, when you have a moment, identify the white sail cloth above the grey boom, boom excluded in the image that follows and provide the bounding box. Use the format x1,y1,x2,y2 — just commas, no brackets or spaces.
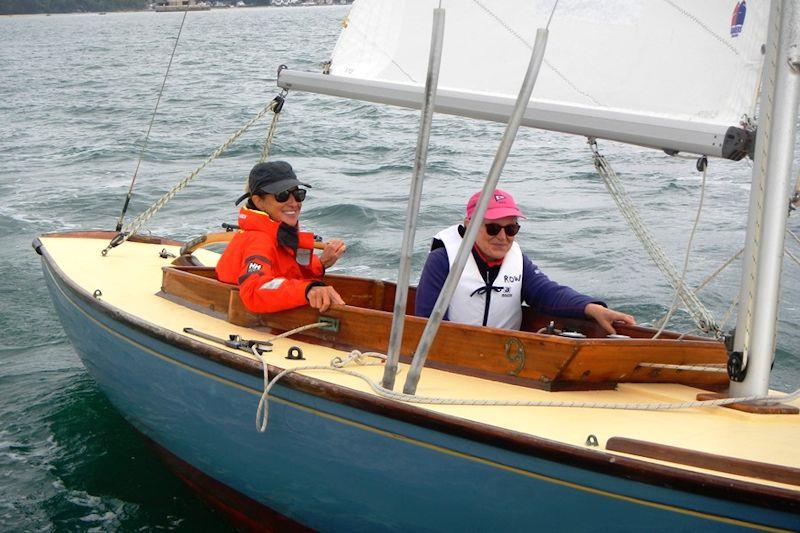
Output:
331,0,769,126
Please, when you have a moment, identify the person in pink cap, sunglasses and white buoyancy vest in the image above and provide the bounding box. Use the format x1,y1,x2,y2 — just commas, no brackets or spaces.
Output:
416,189,635,333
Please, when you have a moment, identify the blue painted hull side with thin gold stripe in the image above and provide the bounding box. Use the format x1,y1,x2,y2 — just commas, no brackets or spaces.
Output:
44,254,800,531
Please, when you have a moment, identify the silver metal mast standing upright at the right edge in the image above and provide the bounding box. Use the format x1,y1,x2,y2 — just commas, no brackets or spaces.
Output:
729,0,800,396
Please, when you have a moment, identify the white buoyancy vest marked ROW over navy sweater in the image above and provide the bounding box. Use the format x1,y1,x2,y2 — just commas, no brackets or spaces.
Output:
436,225,523,329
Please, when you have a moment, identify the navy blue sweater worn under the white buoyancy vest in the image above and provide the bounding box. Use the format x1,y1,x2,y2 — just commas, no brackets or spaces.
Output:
414,234,605,319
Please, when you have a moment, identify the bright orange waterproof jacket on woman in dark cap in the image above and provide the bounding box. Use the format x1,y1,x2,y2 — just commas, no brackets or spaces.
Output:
217,207,324,313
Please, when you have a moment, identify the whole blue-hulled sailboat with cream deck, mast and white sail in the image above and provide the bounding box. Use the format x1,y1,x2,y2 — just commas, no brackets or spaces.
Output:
34,0,800,531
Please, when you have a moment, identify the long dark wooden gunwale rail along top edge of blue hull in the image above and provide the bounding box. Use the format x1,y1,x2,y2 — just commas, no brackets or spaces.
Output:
34,232,800,514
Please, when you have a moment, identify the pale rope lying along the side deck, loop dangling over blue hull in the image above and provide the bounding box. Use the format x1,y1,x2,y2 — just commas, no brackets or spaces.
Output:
253,322,800,433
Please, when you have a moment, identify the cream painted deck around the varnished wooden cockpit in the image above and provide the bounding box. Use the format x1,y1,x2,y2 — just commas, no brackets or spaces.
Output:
41,238,800,492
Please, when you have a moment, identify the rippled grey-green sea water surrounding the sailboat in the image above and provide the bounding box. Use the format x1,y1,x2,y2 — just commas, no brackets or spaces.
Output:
0,7,800,531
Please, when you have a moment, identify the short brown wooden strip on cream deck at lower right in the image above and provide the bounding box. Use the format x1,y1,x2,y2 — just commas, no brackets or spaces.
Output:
606,437,800,486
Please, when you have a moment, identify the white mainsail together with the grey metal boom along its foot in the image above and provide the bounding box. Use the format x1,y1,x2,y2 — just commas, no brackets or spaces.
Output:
279,0,769,157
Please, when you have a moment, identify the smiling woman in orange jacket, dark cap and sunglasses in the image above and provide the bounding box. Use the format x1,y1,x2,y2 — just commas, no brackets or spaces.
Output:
217,161,346,313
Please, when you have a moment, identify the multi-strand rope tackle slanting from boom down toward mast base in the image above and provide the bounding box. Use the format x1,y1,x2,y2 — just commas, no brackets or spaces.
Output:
589,139,720,333
